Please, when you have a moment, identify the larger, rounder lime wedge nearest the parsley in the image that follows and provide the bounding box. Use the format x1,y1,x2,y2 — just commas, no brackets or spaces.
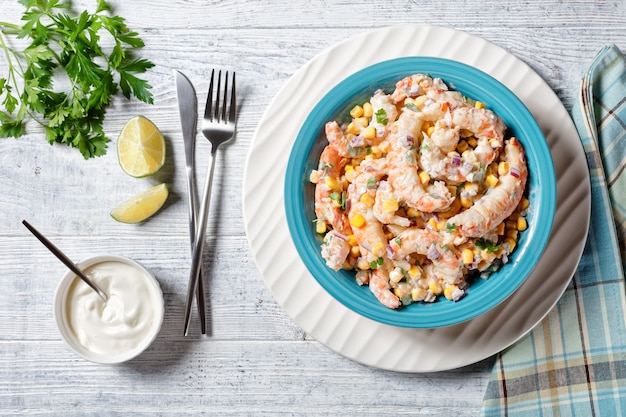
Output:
117,116,165,178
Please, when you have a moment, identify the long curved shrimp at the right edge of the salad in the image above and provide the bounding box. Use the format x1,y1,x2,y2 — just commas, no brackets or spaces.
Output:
448,138,528,237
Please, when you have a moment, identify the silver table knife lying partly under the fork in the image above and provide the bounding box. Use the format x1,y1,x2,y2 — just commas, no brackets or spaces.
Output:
175,71,206,334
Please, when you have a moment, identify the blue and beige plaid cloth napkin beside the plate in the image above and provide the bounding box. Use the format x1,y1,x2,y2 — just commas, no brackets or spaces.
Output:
480,45,626,417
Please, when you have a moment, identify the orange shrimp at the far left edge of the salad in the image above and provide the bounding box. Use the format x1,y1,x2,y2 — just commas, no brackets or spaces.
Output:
315,145,351,234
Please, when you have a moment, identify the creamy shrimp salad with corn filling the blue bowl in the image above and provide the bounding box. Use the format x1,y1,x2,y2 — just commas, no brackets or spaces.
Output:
310,74,529,309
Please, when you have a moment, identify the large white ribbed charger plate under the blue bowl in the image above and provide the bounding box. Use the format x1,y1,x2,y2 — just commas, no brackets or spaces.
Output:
243,25,591,372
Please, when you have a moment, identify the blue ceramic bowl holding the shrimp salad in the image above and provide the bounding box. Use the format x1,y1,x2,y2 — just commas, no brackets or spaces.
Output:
285,57,556,328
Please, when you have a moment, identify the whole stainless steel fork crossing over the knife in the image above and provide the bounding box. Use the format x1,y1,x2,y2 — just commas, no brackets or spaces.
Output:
184,70,237,336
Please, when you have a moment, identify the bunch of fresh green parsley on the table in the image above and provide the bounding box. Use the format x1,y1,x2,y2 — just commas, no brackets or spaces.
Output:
0,0,154,159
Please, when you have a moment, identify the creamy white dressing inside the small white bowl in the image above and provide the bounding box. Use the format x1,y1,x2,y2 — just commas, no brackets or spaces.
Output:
65,261,162,355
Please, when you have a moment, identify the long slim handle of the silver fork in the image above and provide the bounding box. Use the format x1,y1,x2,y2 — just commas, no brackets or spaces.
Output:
184,146,218,336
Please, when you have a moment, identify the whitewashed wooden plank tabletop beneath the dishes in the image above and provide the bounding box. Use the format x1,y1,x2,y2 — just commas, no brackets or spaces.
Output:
0,0,626,416
